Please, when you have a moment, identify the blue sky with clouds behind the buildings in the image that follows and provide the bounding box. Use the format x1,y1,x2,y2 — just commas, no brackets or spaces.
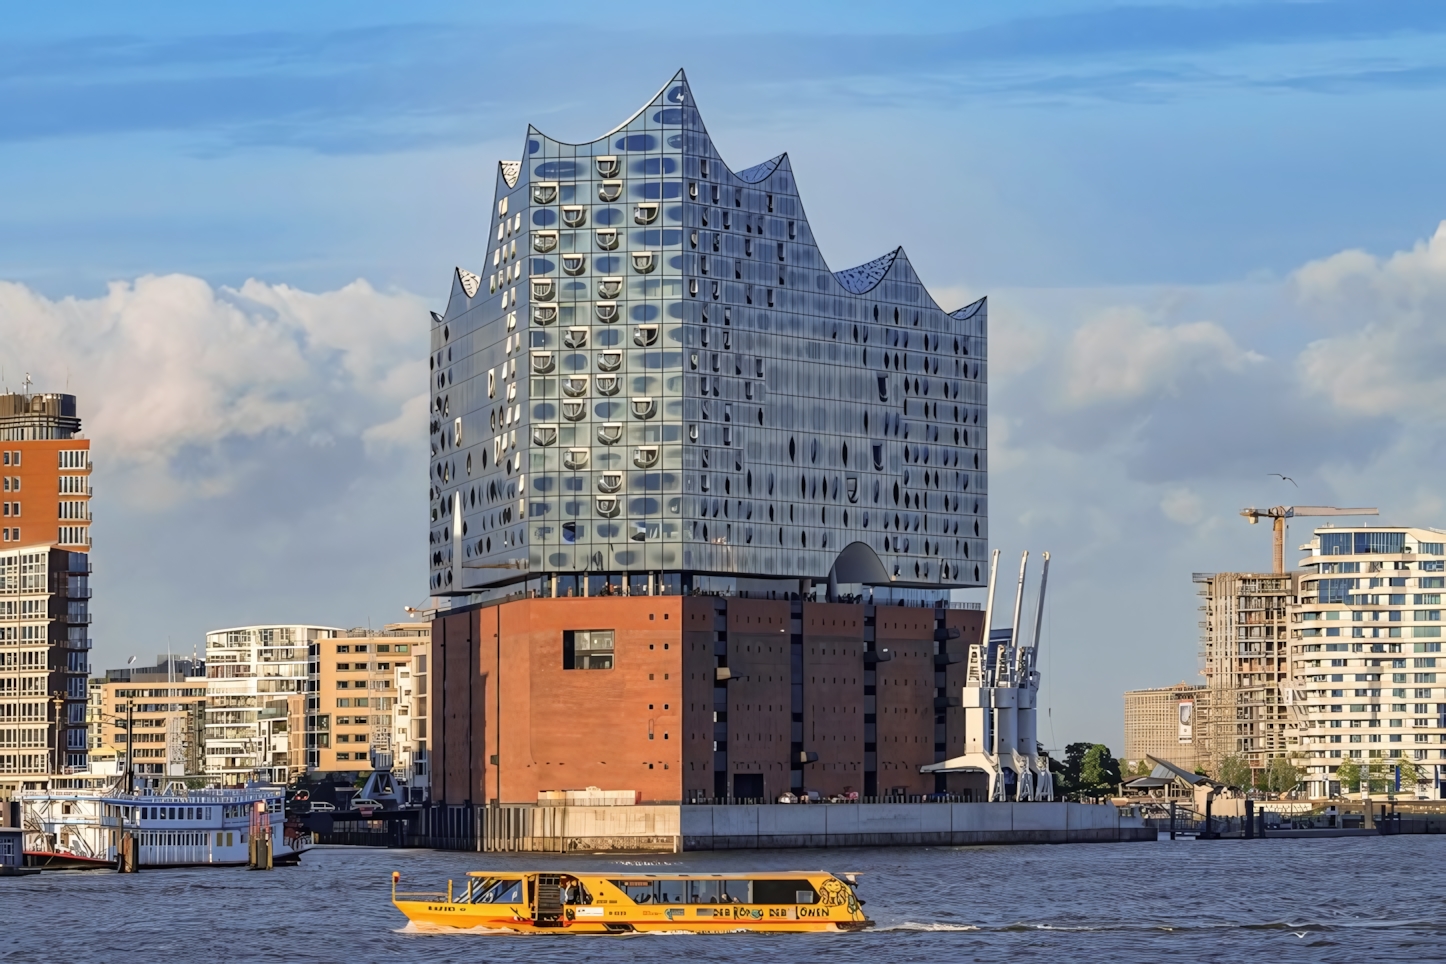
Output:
0,0,1446,749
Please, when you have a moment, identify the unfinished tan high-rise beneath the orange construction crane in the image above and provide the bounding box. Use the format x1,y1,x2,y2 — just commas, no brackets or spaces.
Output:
1194,572,1299,773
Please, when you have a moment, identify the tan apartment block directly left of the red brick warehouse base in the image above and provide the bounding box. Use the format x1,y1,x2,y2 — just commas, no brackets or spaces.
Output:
308,623,431,779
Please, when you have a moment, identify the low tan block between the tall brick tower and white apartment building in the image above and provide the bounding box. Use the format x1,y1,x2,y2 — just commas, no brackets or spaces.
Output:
88,656,207,788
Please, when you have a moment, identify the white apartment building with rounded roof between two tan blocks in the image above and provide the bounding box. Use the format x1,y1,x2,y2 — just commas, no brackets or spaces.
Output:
205,626,343,785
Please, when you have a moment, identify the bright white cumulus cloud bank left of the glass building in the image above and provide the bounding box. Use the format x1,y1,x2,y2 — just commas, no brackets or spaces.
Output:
0,275,427,502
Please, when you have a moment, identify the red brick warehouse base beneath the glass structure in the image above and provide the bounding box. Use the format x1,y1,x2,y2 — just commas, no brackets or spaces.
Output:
432,595,983,805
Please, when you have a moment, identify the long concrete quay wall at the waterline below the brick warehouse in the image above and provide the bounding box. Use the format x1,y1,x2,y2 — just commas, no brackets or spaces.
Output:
497,804,1157,853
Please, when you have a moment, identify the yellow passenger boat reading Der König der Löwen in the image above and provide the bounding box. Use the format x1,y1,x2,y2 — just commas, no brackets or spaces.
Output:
392,870,873,934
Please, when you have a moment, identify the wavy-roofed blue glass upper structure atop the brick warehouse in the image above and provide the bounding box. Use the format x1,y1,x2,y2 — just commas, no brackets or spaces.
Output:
429,71,988,597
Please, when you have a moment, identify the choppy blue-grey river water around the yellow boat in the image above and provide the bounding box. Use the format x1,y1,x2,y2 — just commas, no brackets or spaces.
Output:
0,837,1446,964
